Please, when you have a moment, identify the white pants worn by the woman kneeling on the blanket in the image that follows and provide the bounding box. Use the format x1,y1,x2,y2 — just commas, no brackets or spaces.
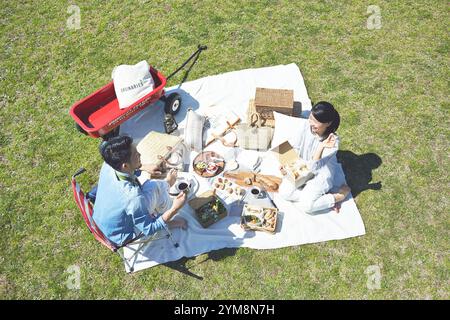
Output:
279,169,335,213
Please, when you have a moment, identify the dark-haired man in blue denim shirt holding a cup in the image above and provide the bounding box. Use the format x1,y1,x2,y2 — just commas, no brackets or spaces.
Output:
93,136,186,246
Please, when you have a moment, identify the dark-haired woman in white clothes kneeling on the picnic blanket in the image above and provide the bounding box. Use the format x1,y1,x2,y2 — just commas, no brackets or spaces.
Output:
279,101,350,214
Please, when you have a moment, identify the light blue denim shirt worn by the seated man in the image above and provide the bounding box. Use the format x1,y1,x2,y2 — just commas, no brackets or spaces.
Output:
93,163,166,246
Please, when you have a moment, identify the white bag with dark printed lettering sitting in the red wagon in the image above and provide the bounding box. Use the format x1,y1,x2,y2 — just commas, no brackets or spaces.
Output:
111,60,155,109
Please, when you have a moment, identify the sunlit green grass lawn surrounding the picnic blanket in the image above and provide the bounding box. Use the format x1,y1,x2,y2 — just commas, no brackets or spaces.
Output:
0,0,450,299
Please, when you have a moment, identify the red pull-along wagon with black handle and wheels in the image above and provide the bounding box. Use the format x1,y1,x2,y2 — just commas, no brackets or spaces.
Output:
69,45,207,139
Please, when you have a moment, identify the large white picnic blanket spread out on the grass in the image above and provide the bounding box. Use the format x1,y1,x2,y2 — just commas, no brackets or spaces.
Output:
121,64,365,272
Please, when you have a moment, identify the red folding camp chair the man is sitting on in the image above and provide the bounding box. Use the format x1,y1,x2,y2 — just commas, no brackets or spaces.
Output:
72,168,179,272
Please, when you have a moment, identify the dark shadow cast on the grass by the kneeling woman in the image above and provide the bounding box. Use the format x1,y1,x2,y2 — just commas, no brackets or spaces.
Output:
336,150,382,198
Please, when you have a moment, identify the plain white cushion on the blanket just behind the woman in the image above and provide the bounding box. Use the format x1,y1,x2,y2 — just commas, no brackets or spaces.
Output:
272,111,308,149
